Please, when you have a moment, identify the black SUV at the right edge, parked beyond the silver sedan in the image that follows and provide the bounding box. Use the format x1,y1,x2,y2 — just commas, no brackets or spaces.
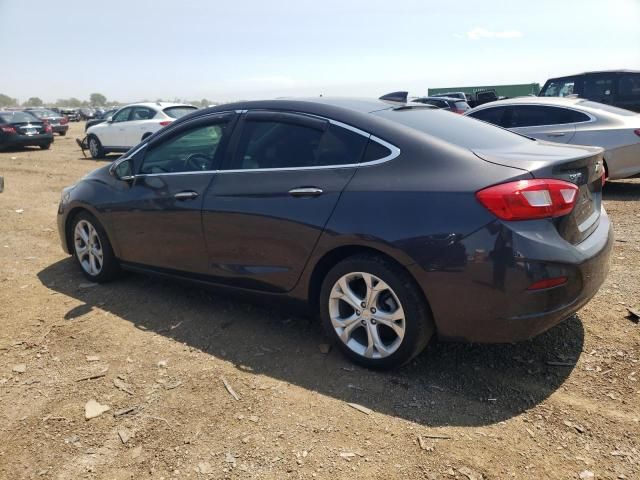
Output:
539,70,640,112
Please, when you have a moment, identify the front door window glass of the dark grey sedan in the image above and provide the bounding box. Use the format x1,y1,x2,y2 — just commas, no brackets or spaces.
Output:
140,123,227,173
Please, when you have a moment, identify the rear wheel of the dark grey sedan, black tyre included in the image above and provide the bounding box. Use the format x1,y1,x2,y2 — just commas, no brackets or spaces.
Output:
320,255,435,368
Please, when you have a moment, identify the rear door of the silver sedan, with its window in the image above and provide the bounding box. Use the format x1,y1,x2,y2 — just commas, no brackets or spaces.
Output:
505,105,576,143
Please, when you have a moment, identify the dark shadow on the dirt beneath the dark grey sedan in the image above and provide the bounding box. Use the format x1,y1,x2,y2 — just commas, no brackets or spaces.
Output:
38,258,584,427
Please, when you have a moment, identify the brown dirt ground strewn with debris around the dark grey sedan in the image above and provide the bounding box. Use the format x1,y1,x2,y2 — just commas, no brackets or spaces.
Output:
0,124,640,480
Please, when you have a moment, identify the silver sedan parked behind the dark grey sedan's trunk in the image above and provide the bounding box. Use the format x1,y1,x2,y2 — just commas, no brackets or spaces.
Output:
464,97,640,180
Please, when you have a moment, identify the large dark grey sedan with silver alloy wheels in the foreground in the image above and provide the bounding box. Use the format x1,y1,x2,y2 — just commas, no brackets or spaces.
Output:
58,97,612,367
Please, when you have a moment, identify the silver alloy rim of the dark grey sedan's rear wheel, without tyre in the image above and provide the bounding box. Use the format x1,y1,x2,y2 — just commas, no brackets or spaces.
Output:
329,272,406,359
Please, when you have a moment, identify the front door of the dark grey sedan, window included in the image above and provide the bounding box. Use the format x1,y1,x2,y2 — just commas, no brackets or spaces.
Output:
109,113,235,273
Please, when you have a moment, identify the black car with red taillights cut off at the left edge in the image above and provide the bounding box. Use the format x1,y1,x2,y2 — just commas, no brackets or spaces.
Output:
0,111,53,150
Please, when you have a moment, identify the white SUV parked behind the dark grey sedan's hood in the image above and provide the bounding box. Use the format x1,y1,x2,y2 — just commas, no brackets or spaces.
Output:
87,102,197,158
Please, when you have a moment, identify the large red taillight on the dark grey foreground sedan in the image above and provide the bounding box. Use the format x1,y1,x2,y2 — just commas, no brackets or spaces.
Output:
476,179,578,220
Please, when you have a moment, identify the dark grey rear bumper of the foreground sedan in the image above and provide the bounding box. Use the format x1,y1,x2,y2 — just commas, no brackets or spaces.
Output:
411,210,613,343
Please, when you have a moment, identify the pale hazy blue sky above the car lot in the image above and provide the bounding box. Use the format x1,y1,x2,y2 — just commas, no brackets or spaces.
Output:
0,0,640,102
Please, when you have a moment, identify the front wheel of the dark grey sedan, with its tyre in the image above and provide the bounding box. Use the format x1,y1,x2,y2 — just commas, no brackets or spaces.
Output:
69,212,120,283
